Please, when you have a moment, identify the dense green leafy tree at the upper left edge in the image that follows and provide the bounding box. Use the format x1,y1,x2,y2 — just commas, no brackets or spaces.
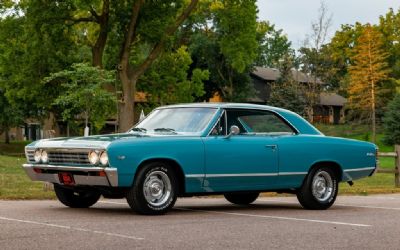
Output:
0,1,83,120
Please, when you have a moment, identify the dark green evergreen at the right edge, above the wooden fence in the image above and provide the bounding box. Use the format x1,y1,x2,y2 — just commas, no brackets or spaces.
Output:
383,94,400,145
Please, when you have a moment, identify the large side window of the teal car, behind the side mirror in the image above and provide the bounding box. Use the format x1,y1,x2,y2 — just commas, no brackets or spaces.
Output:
227,110,294,134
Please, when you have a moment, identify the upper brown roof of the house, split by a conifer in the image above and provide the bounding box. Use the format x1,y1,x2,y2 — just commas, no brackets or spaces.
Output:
252,67,322,84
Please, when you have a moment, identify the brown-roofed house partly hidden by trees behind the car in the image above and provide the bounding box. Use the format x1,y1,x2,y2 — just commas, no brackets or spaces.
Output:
247,67,346,124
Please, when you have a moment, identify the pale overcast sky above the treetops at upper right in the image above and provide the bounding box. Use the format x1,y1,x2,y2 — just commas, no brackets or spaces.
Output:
257,0,400,48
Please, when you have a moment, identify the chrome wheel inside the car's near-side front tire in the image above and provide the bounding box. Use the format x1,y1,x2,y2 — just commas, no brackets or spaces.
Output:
143,171,172,207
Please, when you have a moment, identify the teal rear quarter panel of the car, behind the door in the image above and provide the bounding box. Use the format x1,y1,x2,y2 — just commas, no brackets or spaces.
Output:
278,135,376,187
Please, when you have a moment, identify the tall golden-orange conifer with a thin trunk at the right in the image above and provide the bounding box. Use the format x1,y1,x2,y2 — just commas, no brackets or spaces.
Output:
348,24,390,142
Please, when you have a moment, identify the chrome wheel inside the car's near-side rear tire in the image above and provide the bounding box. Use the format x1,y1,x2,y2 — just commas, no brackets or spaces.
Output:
311,171,334,202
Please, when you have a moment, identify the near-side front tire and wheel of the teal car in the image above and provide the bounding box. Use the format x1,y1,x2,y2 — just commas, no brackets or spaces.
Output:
126,162,178,215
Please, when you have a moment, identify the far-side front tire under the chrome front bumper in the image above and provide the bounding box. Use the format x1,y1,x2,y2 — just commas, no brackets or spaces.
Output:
54,184,101,208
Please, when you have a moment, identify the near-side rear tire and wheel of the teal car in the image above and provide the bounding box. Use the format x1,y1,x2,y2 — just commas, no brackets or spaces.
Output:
296,167,338,210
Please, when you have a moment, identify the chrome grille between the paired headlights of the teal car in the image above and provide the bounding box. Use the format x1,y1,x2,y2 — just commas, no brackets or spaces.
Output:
47,150,90,165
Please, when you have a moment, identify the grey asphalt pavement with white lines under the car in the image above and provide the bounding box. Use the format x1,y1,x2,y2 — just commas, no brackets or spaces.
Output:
0,194,400,250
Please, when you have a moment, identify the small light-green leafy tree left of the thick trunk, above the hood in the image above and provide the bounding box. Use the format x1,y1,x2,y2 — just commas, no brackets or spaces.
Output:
44,64,116,135
